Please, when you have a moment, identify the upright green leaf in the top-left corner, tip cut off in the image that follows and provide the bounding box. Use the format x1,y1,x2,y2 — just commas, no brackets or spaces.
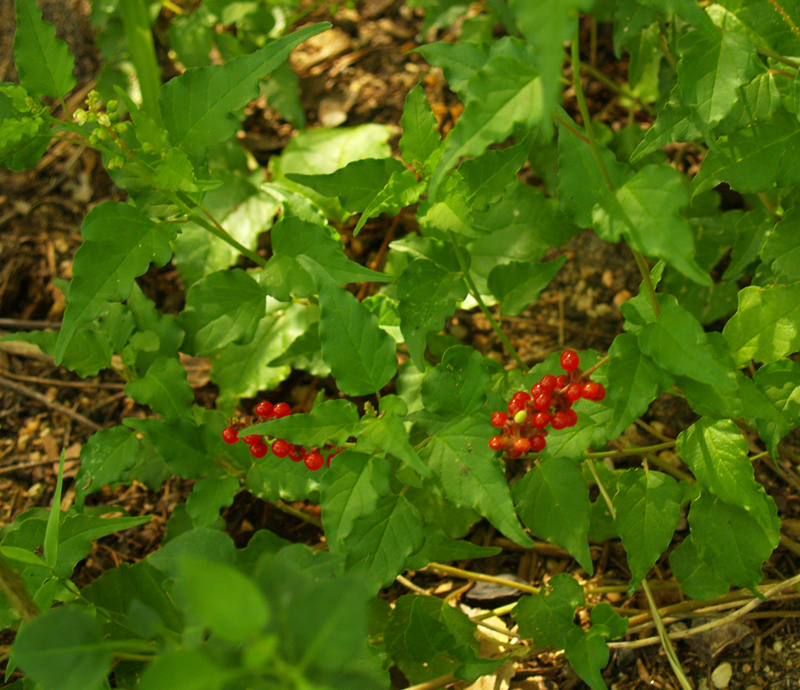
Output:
14,0,75,98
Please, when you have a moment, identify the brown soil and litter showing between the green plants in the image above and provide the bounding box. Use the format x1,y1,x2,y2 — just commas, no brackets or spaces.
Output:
0,0,800,690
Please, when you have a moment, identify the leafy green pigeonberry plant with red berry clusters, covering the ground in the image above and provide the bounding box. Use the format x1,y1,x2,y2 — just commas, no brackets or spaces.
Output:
0,0,800,690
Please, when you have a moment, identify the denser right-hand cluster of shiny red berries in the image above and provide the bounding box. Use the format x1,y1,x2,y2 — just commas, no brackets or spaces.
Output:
489,350,606,458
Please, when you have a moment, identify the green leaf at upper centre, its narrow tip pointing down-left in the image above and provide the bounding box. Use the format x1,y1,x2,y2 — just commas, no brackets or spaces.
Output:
428,55,545,200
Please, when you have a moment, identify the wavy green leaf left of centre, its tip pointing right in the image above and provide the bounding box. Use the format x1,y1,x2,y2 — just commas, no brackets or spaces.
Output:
270,214,392,288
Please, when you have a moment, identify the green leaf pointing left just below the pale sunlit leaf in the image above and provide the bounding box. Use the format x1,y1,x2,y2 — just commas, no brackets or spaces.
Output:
286,158,406,213
